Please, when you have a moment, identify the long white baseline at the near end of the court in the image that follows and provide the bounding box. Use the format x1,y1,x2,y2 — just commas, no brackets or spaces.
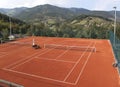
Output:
2,68,75,85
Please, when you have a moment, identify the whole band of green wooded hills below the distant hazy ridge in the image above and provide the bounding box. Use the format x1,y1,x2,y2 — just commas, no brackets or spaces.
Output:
0,14,120,39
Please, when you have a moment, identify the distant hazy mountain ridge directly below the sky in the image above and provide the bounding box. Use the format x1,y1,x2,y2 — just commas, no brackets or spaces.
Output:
0,4,120,22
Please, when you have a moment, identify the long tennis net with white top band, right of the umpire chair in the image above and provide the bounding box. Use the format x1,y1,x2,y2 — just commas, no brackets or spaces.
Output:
44,44,96,52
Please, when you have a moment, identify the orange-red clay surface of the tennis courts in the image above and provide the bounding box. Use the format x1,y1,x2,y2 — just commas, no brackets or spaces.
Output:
0,37,120,87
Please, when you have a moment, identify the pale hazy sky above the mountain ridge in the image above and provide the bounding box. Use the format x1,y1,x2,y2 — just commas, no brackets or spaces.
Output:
0,0,120,10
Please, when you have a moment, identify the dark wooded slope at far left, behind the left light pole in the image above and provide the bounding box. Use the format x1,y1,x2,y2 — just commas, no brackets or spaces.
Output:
0,13,30,40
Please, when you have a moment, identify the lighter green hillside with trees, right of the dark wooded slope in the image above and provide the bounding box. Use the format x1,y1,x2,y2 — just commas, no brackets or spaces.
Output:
29,15,120,39
